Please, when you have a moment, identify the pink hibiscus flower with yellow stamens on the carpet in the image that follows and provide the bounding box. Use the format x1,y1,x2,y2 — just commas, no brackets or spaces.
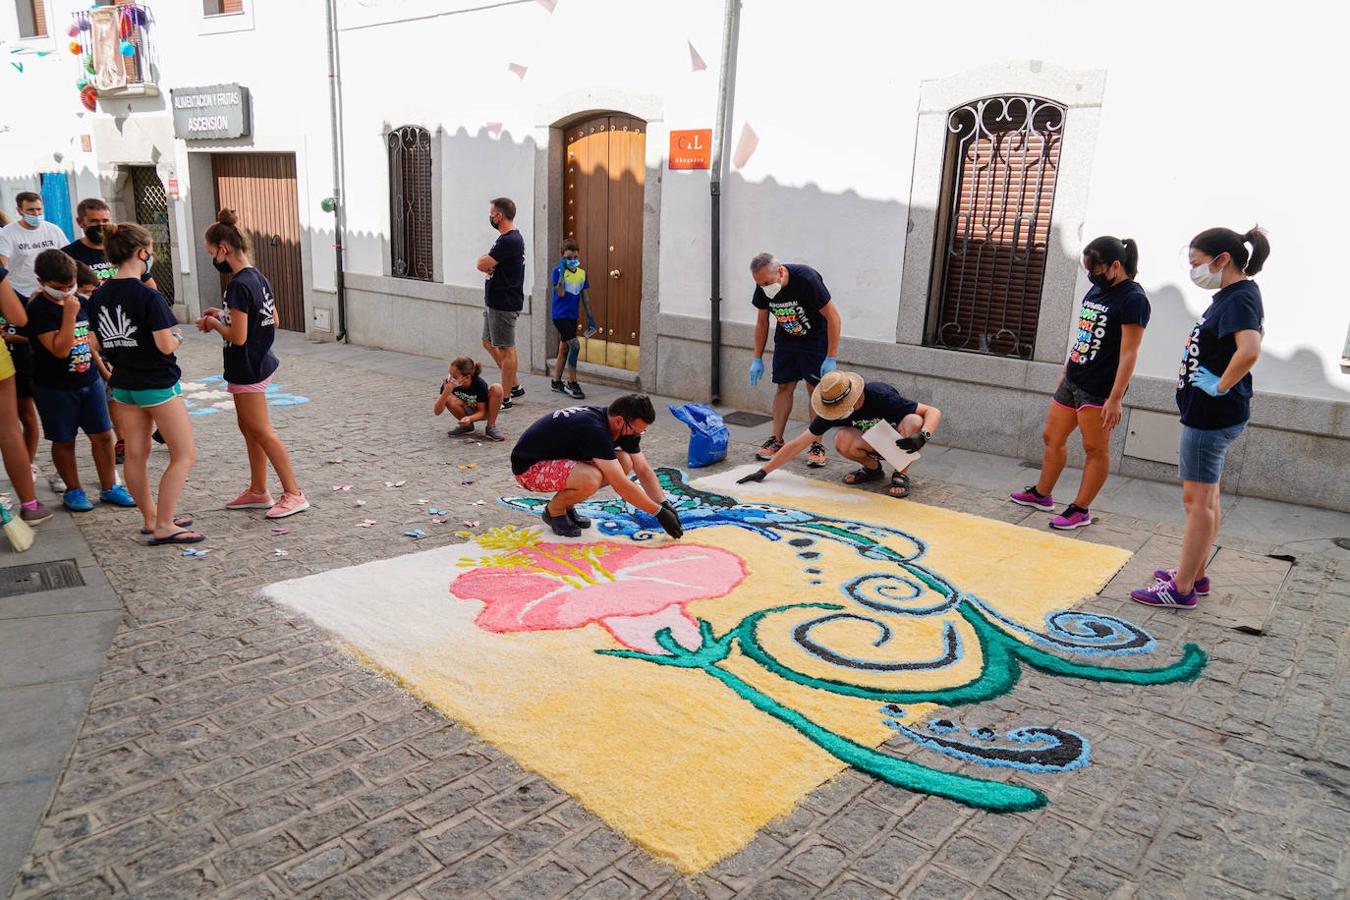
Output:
450,528,747,653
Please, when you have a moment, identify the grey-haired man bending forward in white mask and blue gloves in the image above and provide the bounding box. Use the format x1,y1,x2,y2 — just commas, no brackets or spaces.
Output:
751,254,841,468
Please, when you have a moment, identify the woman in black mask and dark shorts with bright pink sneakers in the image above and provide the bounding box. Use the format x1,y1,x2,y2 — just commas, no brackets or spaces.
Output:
1010,237,1149,532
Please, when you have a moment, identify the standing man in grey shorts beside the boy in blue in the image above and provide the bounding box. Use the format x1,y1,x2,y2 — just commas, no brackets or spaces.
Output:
478,197,525,409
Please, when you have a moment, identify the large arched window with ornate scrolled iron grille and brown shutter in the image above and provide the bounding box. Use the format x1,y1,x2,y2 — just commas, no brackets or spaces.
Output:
925,94,1065,359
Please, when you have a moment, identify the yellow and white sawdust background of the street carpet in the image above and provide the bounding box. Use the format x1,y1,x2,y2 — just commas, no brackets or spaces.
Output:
267,484,1130,873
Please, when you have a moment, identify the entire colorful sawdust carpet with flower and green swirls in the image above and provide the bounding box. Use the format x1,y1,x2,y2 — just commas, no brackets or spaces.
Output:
266,470,1206,873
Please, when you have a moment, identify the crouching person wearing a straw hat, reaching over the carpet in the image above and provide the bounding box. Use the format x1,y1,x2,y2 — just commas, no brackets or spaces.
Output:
737,370,942,498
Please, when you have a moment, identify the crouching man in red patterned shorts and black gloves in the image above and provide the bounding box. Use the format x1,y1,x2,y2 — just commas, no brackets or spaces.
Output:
510,394,684,537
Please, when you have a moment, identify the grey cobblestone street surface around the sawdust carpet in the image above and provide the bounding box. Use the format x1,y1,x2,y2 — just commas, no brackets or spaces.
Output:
5,336,1350,900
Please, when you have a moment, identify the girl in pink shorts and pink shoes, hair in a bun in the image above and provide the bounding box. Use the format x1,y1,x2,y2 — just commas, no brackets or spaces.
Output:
197,209,309,518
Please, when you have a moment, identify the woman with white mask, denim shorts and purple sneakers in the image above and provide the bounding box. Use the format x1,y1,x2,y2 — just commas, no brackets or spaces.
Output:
1130,228,1270,610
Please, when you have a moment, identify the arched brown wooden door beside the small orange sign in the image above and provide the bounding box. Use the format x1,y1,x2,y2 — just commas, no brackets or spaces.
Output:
563,115,647,371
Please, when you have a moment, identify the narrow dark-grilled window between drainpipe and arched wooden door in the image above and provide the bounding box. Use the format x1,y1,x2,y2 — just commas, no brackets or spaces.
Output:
389,125,433,281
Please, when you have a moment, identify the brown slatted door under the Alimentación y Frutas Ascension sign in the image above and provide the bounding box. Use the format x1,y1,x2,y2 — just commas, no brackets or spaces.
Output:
211,152,305,332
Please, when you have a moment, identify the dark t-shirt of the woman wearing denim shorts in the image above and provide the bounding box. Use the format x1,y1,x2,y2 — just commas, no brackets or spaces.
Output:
1177,279,1265,430
